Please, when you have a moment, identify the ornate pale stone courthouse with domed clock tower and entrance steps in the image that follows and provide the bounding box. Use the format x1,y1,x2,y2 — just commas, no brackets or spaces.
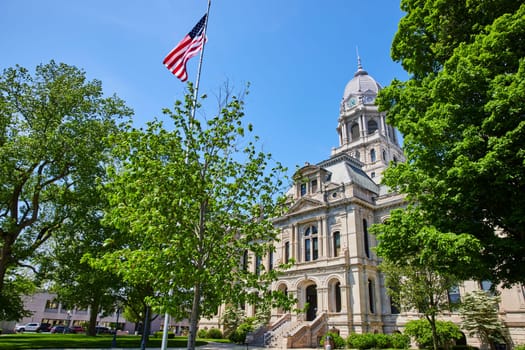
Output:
201,62,525,348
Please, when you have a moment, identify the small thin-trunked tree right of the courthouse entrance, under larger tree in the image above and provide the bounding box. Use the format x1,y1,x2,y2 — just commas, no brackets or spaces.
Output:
371,206,480,350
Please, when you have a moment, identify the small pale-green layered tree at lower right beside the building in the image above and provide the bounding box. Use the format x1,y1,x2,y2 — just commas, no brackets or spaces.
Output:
459,290,505,350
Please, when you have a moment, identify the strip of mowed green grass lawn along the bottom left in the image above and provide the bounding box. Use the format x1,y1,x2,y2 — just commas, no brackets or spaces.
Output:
0,333,221,350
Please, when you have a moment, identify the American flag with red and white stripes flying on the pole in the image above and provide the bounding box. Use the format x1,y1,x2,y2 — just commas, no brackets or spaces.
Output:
162,15,206,81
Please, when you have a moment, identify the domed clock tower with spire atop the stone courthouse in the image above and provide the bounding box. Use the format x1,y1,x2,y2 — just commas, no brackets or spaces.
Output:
332,58,405,183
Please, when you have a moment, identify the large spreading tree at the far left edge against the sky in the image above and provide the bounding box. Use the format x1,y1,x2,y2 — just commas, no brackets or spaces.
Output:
0,61,132,319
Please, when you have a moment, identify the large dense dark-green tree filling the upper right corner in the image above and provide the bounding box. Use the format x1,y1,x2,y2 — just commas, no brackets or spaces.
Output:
378,0,525,285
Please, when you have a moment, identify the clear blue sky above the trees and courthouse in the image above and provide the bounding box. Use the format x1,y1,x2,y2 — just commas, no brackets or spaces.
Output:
0,0,407,174
